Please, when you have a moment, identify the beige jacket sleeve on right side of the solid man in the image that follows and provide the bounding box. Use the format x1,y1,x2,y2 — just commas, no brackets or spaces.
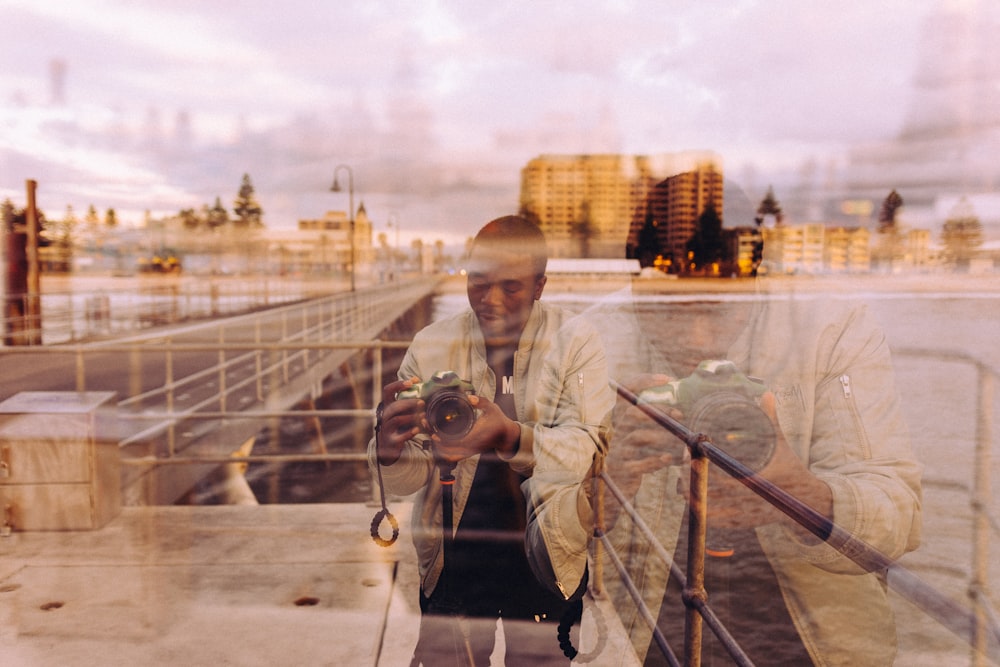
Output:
522,318,614,599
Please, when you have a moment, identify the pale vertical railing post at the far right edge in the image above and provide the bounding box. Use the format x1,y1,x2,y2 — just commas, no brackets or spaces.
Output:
969,366,994,667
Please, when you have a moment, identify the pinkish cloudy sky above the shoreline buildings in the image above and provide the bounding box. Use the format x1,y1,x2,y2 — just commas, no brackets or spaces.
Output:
0,0,996,245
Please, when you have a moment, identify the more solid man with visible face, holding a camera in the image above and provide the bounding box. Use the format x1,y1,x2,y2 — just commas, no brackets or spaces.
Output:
369,216,614,665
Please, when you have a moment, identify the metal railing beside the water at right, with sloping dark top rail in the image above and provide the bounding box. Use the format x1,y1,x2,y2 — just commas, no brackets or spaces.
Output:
595,349,1000,666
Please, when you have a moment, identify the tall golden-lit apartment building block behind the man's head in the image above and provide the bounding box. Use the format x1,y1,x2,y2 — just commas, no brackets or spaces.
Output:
520,152,722,258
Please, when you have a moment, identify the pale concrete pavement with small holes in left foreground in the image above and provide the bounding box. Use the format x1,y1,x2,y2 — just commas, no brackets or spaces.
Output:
0,503,419,667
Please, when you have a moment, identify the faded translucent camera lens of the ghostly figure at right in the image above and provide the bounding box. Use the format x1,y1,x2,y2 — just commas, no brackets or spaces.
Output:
688,392,775,472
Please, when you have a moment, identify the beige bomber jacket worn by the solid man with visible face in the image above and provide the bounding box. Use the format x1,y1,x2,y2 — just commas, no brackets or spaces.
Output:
368,301,614,595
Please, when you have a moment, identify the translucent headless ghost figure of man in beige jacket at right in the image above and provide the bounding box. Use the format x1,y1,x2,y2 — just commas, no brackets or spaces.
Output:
528,222,921,665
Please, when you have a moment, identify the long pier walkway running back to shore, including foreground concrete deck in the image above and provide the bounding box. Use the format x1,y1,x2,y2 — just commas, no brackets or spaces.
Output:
0,281,446,667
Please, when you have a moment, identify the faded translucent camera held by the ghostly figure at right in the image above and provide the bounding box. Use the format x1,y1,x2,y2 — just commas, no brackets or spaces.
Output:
639,360,775,472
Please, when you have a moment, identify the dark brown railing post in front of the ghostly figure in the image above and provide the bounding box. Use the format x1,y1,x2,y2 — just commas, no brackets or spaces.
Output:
684,443,709,667
